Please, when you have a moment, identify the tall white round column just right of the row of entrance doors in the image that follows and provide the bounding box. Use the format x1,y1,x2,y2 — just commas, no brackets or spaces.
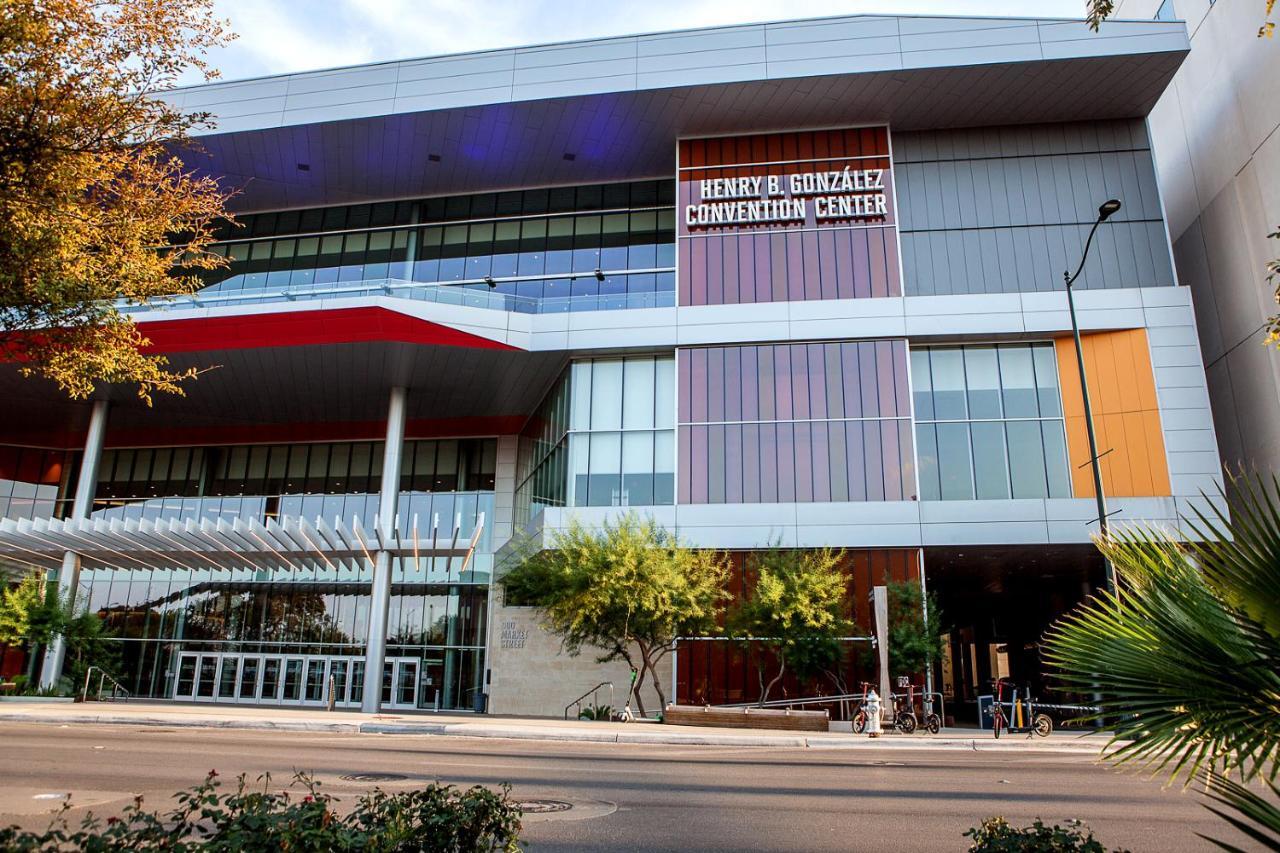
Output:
360,387,406,713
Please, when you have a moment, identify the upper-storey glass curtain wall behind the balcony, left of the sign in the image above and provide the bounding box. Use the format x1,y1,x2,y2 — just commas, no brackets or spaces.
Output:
205,181,676,310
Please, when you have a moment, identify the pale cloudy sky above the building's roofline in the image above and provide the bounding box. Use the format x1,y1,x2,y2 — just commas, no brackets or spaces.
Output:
182,0,1085,83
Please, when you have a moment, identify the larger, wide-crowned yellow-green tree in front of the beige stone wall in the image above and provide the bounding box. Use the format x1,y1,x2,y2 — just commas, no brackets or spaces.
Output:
502,514,728,715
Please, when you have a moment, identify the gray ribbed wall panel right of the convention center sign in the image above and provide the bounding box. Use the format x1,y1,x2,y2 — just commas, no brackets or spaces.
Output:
893,119,1174,296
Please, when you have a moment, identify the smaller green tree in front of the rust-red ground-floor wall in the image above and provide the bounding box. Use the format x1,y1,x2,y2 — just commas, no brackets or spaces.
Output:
728,547,854,704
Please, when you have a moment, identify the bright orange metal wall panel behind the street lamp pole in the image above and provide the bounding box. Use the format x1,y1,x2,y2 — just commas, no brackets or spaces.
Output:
1055,329,1170,497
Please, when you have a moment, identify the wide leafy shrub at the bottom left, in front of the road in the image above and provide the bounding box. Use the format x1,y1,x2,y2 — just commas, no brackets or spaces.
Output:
0,771,521,853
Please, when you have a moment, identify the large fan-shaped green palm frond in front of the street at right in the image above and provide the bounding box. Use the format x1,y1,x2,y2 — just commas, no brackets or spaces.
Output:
1046,528,1280,781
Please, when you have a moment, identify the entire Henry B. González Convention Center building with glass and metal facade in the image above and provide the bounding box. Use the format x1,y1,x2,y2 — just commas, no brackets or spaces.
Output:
0,15,1221,717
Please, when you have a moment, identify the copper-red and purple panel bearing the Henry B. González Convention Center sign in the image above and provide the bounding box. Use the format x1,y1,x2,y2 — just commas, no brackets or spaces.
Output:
676,127,902,306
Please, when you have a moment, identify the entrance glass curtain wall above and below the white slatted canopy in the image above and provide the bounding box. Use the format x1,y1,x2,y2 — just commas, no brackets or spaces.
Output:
66,438,497,708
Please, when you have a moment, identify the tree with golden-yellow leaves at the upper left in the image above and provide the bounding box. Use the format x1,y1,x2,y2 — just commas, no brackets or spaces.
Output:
0,0,232,403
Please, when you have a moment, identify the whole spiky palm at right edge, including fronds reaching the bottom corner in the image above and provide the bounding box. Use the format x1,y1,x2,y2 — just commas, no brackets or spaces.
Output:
1046,476,1280,848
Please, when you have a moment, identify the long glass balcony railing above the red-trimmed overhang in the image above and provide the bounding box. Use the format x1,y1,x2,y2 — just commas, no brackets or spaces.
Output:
116,268,676,314
